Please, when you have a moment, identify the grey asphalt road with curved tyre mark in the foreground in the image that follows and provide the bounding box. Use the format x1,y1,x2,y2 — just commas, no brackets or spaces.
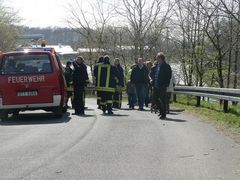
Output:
0,99,240,180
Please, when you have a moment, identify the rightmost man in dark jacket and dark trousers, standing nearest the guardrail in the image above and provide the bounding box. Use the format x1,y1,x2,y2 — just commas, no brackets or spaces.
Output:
150,53,172,119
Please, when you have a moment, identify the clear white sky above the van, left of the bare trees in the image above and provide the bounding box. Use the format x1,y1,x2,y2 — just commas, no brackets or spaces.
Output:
3,0,70,28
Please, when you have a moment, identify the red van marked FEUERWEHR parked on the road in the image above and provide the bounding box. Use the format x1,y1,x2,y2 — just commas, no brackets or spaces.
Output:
0,48,66,120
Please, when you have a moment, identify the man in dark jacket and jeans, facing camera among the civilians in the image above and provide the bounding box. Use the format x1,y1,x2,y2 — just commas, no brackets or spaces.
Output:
130,58,149,111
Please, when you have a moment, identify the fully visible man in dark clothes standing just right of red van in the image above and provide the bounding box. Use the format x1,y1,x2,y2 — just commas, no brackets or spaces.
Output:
73,56,89,115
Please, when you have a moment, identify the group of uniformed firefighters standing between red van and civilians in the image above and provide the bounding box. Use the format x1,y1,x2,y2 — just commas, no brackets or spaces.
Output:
65,56,124,115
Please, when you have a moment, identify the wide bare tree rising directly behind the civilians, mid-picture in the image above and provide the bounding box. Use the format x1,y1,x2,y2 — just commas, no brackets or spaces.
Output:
116,0,173,59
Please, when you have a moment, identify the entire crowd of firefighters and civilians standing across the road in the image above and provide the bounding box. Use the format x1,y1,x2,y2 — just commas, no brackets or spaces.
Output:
65,53,173,119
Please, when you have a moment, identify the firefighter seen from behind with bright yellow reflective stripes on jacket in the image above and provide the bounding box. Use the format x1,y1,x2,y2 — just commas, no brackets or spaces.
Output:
94,56,119,114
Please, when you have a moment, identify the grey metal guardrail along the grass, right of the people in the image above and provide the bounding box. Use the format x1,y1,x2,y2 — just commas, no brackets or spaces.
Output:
174,86,240,112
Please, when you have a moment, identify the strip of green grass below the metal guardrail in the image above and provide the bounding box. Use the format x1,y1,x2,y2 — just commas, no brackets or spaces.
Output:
174,96,240,130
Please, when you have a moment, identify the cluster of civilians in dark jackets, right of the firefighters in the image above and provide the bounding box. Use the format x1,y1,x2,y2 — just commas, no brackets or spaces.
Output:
127,53,175,119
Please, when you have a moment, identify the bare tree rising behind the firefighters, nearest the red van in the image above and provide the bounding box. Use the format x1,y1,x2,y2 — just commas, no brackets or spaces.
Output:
66,0,112,71
